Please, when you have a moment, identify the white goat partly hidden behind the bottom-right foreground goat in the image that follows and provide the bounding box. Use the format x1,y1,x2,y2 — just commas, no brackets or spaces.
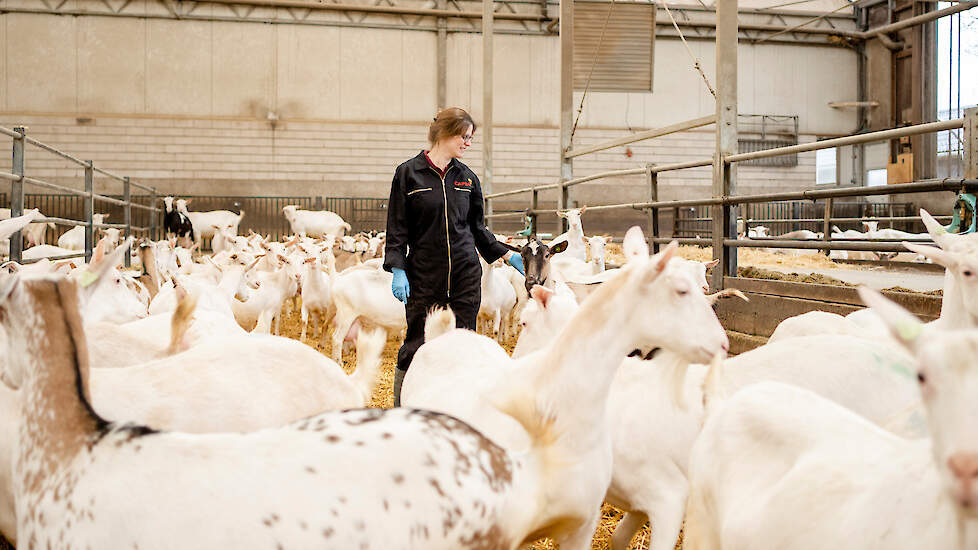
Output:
606,336,926,550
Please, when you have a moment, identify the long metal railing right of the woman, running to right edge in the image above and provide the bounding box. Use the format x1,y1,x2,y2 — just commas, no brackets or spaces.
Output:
486,108,978,287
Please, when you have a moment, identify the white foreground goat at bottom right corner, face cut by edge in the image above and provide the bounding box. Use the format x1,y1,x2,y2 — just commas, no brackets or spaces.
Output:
684,289,978,550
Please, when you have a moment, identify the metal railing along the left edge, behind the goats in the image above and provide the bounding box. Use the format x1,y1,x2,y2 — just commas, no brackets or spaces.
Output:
0,127,160,267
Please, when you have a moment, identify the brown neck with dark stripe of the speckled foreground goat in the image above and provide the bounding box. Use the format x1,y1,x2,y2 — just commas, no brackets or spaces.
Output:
2,279,108,490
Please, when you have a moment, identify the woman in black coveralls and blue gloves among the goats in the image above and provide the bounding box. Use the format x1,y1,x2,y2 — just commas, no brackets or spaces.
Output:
384,107,523,406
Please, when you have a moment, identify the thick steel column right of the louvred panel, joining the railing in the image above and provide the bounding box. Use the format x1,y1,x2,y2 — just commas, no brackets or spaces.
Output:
712,0,737,291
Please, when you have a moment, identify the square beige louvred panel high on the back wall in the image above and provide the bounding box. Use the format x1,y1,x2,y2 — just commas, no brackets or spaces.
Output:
574,2,655,92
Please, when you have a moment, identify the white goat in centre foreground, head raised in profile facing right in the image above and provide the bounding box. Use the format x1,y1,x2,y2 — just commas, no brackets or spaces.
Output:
402,227,728,550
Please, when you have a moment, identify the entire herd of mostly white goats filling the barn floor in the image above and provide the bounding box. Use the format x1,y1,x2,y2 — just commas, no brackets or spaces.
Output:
0,197,978,550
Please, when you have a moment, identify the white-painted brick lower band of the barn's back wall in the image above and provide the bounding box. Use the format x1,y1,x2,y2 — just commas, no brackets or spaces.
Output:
0,114,815,235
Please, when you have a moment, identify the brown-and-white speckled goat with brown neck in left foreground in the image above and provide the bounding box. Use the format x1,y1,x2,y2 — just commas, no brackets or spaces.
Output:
0,278,580,550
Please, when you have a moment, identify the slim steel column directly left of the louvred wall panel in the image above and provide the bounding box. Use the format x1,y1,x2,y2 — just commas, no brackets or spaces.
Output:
557,0,574,233
